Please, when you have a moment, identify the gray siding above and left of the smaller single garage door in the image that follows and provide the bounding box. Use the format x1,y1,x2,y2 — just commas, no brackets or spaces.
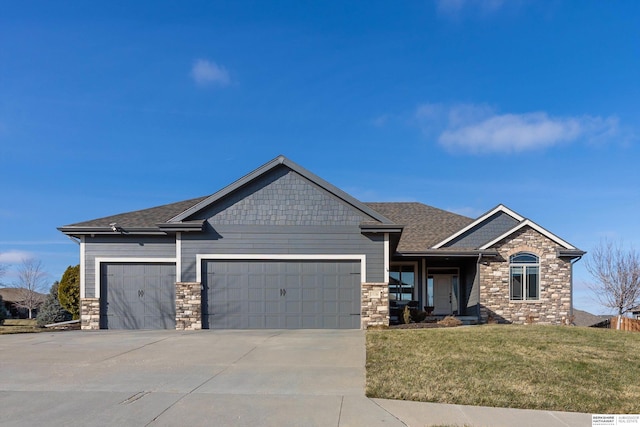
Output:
84,235,176,298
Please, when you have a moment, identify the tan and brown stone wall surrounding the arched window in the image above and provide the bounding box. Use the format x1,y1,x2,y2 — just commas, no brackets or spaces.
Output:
480,227,571,325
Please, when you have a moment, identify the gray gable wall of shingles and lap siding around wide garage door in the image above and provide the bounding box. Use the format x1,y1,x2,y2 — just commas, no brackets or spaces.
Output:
182,166,384,282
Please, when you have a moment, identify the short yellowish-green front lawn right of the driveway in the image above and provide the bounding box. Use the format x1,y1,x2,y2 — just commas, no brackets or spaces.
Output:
367,325,640,414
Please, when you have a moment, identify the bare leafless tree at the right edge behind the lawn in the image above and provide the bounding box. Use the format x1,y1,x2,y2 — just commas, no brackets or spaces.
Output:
585,240,640,329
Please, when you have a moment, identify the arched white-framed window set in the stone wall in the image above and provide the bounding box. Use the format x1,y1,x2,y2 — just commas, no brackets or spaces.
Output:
509,252,540,301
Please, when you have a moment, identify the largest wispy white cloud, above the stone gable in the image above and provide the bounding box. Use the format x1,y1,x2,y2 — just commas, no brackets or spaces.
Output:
414,104,619,153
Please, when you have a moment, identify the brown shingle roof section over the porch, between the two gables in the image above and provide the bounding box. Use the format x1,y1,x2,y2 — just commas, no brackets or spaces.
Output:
365,202,474,252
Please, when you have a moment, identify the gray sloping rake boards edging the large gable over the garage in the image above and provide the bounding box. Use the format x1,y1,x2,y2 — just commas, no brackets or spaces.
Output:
168,156,393,224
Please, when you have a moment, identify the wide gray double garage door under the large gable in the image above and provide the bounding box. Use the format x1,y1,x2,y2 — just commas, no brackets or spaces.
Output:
202,261,361,329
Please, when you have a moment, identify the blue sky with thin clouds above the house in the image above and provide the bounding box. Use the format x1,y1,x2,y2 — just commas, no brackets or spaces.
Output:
0,0,640,312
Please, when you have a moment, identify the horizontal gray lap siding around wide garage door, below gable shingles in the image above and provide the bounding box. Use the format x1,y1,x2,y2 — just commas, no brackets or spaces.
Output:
182,226,384,282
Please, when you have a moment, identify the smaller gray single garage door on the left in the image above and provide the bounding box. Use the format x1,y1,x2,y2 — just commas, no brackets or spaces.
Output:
100,263,176,329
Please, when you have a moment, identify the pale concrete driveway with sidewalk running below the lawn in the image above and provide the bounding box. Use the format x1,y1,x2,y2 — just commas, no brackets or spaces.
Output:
0,330,591,427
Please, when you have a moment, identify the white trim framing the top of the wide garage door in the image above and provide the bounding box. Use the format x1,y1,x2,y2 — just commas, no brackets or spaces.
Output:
196,254,367,283
